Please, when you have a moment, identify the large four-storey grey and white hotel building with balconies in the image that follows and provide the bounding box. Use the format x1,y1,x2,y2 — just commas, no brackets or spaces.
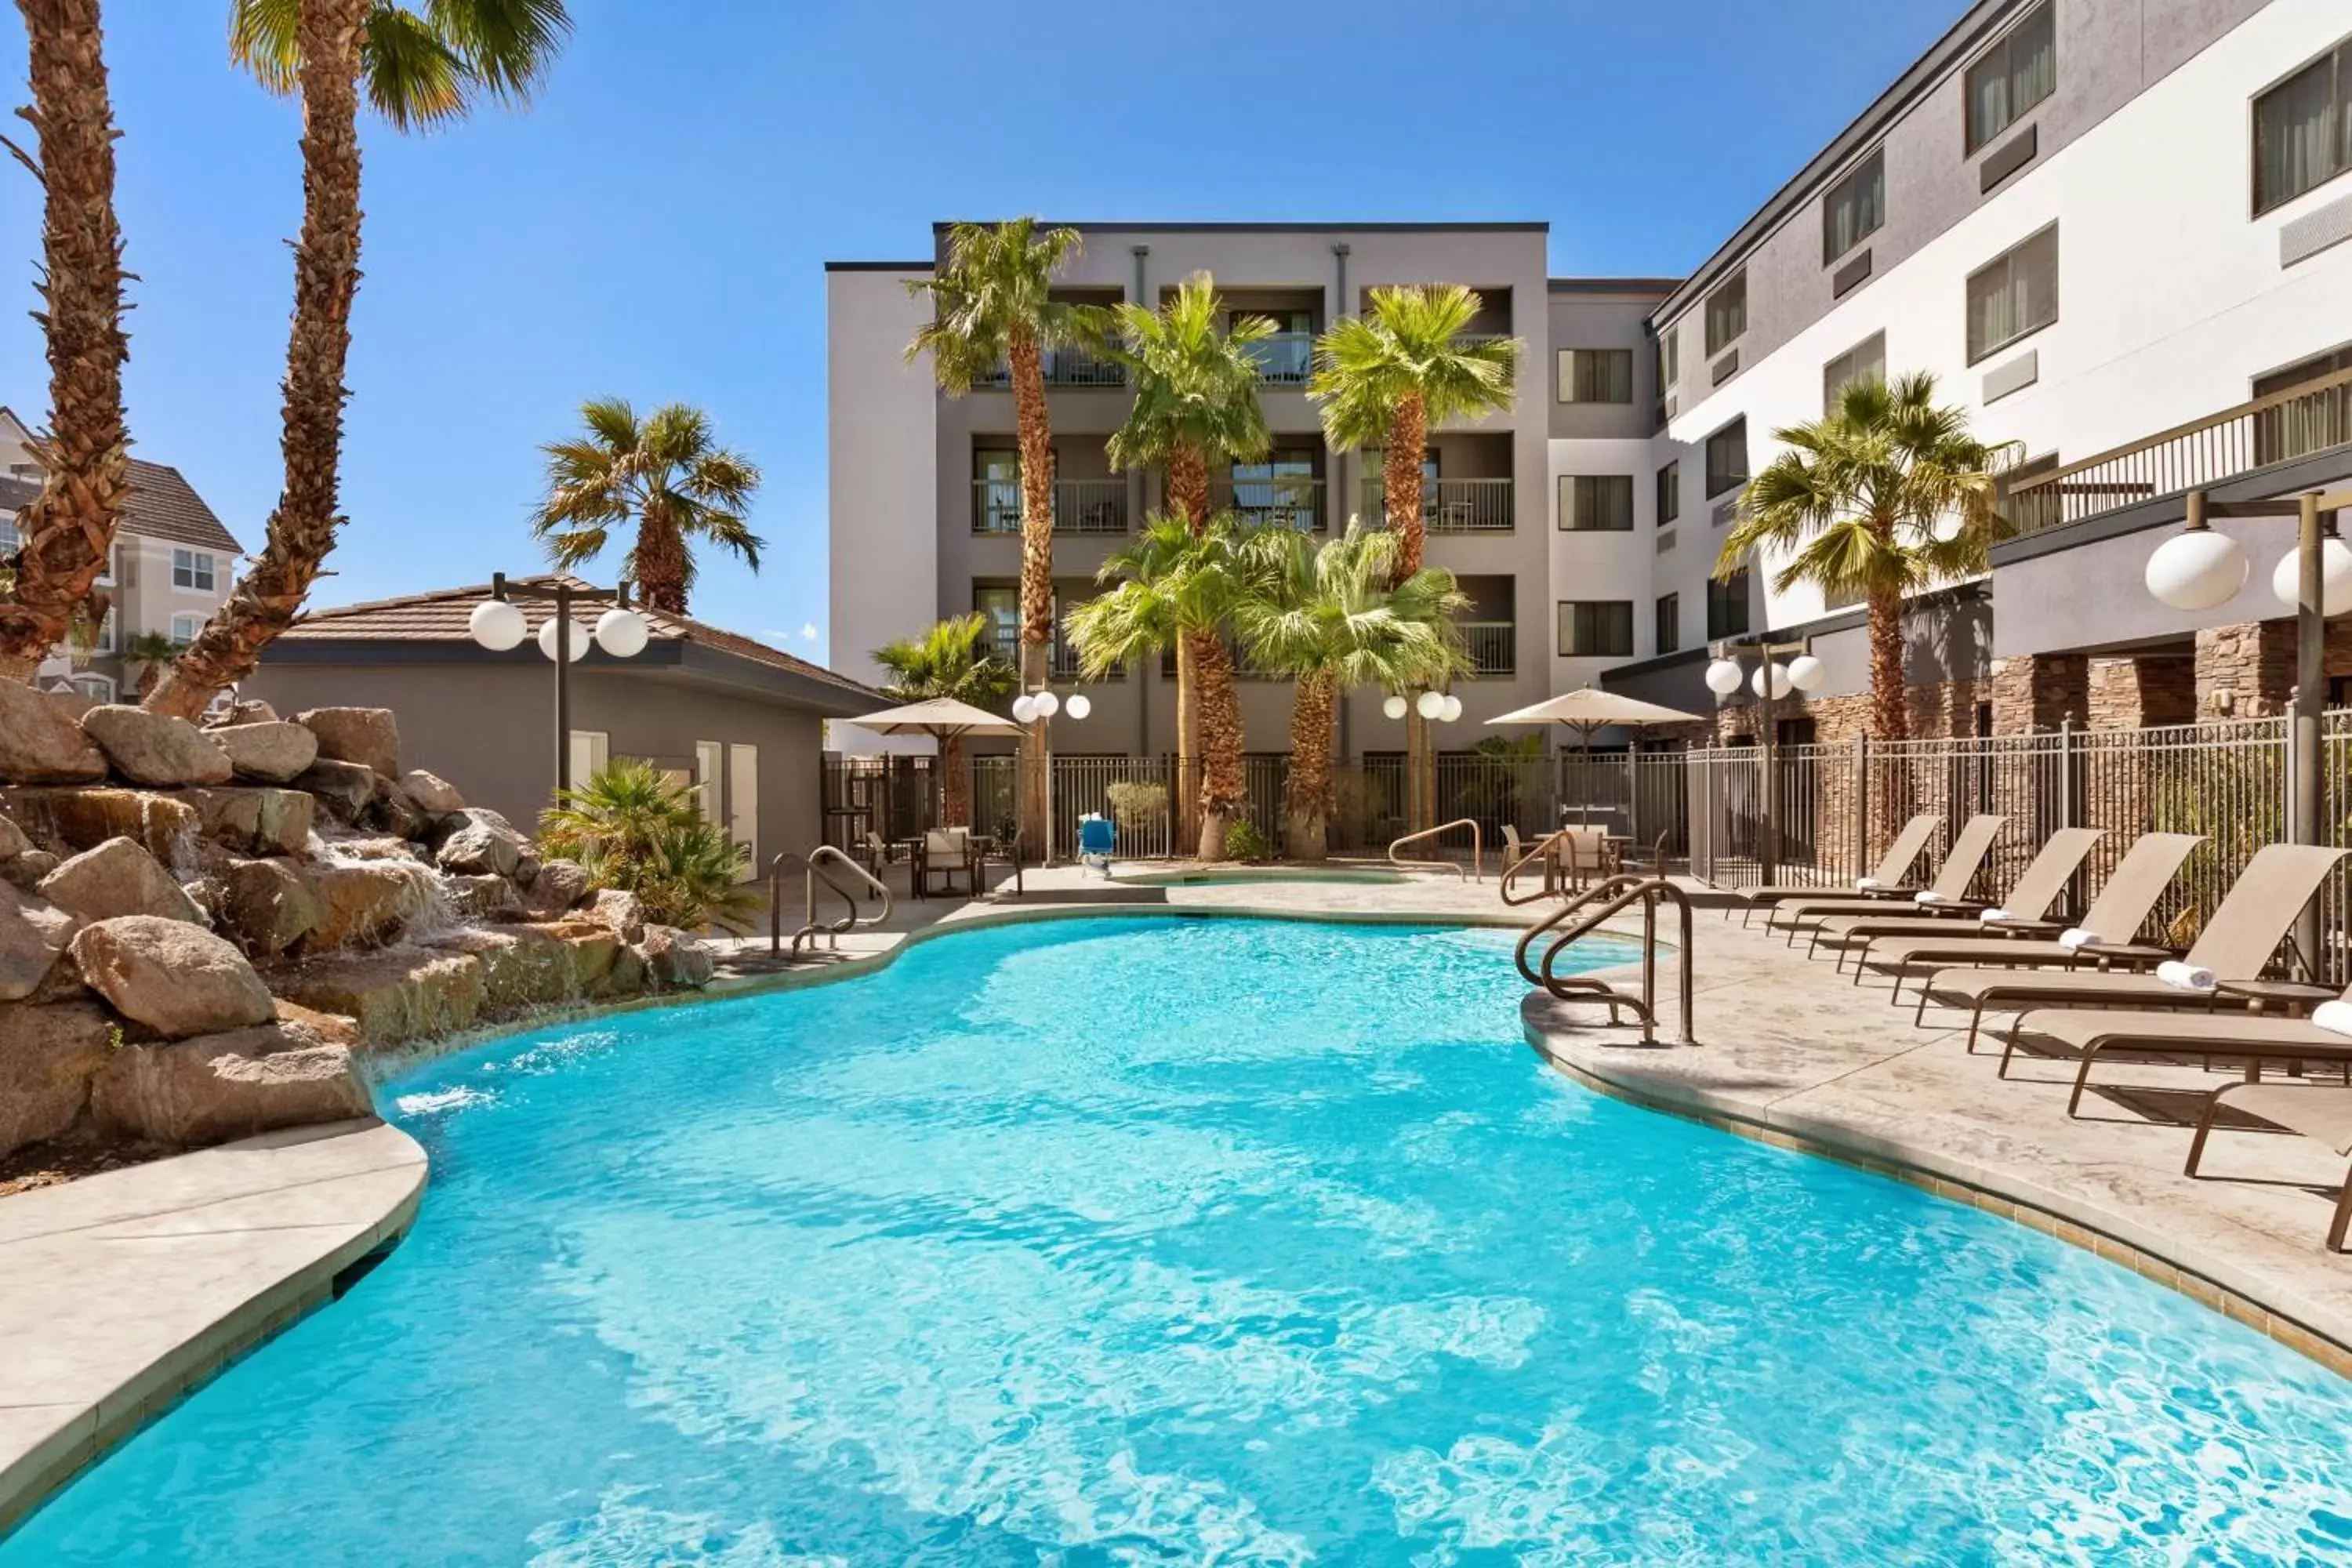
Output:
828,0,2352,757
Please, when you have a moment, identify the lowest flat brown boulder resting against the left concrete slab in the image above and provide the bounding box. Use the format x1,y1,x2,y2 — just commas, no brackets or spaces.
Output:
89,1018,374,1147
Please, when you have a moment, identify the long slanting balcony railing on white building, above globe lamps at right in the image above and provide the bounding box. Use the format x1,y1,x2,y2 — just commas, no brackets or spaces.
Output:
2006,372,2352,534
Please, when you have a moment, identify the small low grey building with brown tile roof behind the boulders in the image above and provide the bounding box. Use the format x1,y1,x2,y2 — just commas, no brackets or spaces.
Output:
240,576,889,865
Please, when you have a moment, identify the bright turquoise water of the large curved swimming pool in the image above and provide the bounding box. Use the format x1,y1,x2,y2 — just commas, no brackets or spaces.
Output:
0,919,2352,1568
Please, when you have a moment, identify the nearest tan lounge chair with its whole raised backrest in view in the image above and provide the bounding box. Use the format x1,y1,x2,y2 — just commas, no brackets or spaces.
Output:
1922,844,2345,1053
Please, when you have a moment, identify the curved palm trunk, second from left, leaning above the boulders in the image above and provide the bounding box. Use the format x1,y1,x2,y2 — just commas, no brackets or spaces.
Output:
146,0,369,720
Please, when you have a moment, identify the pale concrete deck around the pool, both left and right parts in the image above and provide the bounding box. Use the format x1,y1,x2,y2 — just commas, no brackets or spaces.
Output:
0,867,2352,1533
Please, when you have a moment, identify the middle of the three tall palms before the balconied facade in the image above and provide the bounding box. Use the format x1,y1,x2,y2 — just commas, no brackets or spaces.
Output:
1103,273,1275,851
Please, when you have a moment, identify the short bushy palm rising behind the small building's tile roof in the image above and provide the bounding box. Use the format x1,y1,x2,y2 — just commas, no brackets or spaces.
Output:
532,397,767,616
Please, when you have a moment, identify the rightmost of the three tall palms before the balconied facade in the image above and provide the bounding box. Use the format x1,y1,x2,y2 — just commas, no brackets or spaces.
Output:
1308,285,1519,827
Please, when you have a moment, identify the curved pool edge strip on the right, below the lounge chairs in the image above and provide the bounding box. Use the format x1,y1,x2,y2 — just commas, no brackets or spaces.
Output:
1519,992,2352,1377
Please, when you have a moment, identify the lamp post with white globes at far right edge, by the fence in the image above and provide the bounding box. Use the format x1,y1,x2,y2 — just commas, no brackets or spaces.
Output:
2145,489,2352,975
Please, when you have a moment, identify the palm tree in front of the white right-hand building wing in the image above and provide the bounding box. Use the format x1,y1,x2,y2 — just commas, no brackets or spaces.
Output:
1715,372,2018,741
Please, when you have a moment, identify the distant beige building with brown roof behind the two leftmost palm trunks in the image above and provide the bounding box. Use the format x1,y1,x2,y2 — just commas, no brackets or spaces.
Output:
0,407,242,703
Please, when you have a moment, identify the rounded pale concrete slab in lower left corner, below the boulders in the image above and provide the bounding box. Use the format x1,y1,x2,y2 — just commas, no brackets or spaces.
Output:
0,1116,426,1537
